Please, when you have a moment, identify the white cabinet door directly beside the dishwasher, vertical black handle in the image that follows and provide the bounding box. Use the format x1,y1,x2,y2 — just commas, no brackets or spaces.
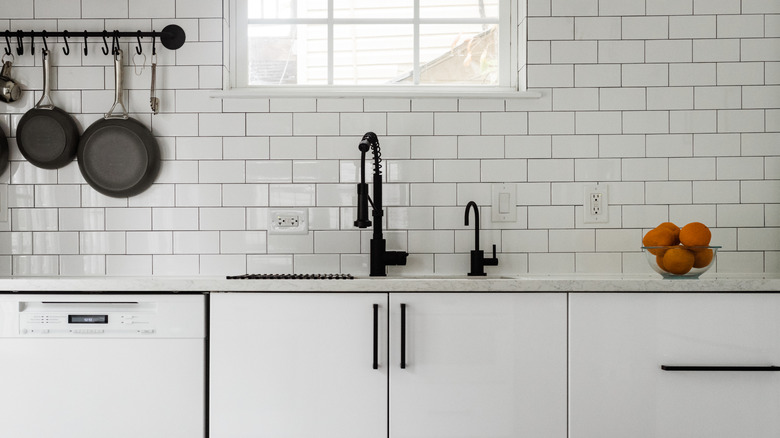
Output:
210,293,387,438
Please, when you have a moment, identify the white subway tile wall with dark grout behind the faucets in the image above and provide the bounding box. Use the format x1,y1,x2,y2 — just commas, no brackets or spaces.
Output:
0,0,780,276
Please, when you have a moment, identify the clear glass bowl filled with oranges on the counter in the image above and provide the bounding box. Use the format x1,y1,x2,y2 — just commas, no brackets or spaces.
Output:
642,222,720,279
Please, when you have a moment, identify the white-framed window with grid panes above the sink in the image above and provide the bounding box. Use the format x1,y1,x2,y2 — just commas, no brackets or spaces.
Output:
230,0,524,95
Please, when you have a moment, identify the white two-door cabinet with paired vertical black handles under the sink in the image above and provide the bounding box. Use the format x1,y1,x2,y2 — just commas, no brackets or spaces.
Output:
210,293,567,438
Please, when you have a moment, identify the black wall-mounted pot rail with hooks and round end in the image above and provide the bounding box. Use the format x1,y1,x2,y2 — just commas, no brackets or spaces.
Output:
2,24,187,56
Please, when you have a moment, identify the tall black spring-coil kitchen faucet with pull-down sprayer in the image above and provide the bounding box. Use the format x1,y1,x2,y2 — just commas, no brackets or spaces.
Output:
355,132,409,277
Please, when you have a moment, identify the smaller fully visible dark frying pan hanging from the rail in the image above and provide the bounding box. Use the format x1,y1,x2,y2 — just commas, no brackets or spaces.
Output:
16,50,79,169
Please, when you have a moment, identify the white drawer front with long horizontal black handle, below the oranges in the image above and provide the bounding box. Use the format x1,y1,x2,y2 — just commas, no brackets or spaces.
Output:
569,293,780,438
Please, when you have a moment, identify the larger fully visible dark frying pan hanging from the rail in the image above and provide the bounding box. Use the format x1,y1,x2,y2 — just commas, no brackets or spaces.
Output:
77,50,160,198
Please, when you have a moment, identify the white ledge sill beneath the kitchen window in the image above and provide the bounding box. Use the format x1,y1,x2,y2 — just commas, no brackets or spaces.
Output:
211,86,542,99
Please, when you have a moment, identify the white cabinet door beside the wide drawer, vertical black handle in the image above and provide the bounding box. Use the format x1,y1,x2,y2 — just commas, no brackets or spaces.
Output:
389,293,566,438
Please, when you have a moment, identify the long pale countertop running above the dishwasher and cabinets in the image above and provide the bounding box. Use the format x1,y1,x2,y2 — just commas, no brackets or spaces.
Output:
0,274,780,293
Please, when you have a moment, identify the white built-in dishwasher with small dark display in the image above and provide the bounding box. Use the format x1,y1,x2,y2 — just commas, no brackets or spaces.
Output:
0,293,206,438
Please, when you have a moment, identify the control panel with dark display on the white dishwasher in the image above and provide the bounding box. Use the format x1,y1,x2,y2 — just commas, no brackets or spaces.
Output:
19,301,157,337
